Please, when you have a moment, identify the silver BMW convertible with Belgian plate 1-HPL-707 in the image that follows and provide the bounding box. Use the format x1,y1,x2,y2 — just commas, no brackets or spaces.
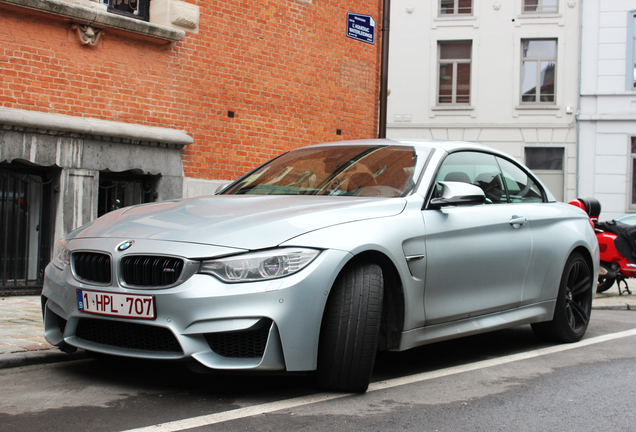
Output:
42,140,599,392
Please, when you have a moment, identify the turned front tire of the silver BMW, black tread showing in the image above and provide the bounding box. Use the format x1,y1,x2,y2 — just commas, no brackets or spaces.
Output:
313,263,384,393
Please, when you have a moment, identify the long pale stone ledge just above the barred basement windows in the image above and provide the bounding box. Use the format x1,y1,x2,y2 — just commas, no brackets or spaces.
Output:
0,107,193,149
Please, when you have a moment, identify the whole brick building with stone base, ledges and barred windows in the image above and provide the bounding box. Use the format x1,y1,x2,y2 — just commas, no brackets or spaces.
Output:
0,0,382,292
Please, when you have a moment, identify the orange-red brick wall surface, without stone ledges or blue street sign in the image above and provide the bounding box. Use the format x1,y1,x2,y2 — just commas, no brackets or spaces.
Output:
0,0,382,180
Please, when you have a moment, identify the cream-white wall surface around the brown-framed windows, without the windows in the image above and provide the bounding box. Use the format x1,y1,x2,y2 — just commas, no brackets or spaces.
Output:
387,0,580,200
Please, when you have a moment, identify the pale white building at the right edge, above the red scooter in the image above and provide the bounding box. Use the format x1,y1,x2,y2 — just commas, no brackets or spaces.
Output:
578,0,636,220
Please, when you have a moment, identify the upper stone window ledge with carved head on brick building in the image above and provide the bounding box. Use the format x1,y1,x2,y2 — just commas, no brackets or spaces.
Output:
0,0,185,42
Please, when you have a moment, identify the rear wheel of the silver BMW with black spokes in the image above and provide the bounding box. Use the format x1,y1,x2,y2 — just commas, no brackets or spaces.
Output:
532,253,594,343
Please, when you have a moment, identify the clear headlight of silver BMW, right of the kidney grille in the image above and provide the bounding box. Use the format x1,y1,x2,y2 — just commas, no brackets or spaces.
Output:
199,248,320,282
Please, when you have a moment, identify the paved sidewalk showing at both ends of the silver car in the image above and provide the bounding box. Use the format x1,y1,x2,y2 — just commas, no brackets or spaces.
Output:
0,285,636,369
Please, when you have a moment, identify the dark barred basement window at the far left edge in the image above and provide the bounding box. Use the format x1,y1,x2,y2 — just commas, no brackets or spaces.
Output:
0,164,51,295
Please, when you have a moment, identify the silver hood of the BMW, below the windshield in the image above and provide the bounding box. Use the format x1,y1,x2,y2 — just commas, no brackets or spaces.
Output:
68,195,406,250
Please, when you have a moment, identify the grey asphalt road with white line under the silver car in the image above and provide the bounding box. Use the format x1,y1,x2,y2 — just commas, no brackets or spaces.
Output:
0,310,636,432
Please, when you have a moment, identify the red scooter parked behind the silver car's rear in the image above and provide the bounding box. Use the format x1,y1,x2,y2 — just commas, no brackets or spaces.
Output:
568,198,636,295
